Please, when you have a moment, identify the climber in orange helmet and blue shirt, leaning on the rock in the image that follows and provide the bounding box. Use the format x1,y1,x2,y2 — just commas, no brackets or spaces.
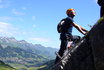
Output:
55,8,88,64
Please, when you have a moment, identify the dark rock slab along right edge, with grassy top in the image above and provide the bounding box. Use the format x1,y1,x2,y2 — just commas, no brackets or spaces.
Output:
89,17,104,70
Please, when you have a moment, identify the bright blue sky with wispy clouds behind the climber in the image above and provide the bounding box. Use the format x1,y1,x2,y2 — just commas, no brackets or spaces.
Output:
0,0,100,48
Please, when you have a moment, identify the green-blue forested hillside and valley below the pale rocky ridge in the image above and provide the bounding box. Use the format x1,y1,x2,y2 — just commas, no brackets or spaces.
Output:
0,46,48,68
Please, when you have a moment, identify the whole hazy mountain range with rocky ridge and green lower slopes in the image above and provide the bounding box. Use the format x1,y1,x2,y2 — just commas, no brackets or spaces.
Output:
0,37,57,70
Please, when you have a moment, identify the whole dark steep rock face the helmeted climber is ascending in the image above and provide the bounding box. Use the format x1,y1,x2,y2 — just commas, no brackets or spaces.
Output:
51,17,104,70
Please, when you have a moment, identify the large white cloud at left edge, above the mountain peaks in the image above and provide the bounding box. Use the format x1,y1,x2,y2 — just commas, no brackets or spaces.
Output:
0,22,36,37
